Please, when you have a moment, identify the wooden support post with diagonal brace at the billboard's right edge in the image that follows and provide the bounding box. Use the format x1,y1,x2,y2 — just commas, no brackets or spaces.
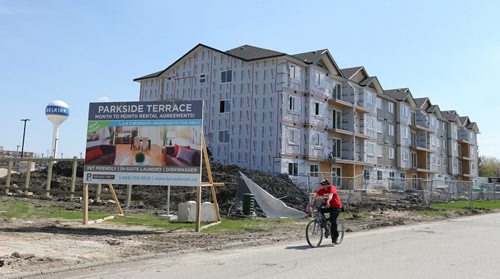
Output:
195,134,224,232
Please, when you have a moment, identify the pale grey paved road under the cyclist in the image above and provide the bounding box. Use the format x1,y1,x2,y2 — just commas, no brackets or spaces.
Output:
35,214,500,279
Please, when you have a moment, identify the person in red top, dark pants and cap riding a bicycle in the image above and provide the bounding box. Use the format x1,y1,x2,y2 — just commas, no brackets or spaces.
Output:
309,179,342,243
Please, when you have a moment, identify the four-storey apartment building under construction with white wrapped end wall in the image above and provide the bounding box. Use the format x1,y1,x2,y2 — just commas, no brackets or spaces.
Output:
134,44,479,187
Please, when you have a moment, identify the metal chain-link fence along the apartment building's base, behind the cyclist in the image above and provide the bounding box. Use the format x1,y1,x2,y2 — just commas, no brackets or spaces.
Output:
295,173,500,207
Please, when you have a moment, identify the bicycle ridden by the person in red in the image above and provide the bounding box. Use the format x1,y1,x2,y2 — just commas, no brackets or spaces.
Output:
306,204,344,248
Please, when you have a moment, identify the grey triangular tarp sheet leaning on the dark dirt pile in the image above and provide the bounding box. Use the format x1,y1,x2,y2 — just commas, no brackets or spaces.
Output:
240,172,307,218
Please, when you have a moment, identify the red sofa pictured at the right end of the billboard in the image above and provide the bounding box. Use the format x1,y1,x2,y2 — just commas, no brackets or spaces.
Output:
162,144,201,167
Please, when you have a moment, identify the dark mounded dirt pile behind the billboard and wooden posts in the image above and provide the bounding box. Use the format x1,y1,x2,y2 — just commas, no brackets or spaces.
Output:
0,162,308,215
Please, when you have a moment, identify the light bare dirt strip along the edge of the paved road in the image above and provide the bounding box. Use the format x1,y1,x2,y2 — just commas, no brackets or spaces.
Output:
0,199,494,278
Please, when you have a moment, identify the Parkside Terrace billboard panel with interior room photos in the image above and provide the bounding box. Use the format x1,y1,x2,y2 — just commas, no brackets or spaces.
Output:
83,100,203,186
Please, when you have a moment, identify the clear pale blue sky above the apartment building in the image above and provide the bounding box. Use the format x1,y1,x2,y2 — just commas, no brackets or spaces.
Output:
0,0,500,158
